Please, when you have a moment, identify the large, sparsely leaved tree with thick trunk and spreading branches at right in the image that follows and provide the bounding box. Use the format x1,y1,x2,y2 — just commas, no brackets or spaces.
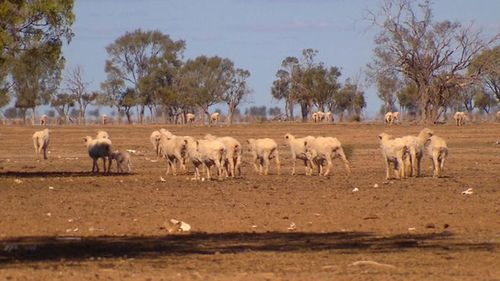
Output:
368,0,499,123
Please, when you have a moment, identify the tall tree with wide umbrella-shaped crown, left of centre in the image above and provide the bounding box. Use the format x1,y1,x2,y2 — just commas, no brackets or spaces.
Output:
105,29,185,123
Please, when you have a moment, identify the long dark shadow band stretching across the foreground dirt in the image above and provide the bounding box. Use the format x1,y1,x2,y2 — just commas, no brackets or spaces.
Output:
0,232,498,265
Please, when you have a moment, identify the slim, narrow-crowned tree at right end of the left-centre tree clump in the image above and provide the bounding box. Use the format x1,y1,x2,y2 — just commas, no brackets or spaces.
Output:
222,68,250,124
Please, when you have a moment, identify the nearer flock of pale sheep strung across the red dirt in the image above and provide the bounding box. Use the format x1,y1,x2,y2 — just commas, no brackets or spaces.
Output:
33,124,448,180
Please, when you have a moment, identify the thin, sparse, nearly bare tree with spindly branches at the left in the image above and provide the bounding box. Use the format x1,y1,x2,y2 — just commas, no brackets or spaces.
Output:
65,65,95,124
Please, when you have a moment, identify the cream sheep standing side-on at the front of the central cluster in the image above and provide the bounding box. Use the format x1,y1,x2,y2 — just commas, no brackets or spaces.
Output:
184,138,227,179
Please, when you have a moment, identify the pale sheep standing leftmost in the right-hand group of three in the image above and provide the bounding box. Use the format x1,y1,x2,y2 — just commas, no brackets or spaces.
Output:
378,133,409,179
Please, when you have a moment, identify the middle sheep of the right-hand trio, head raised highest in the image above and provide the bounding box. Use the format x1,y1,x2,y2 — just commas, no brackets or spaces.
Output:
401,128,434,176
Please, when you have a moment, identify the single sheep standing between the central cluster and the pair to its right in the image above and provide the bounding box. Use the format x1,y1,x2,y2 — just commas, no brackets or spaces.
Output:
247,138,280,175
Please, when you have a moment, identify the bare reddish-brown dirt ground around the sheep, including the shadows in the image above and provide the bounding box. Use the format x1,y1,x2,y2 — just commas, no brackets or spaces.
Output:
0,123,500,281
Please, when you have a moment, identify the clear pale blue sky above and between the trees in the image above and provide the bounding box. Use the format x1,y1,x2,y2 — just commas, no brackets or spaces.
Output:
64,0,500,115
